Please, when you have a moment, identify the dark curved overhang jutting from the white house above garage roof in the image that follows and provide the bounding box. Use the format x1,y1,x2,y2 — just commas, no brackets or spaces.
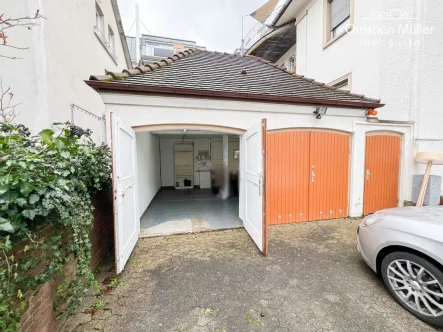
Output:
246,21,297,63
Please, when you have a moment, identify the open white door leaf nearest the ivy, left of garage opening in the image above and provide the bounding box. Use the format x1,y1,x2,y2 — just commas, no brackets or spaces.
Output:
109,113,140,273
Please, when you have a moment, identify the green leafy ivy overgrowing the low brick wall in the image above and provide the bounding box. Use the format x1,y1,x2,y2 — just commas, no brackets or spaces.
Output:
0,122,111,331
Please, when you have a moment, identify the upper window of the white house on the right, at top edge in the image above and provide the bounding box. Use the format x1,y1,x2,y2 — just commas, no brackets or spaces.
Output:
324,0,353,44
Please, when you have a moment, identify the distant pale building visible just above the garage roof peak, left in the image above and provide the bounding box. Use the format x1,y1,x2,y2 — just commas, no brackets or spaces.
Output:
126,35,206,66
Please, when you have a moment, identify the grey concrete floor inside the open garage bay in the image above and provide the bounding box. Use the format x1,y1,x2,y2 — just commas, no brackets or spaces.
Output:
140,188,243,237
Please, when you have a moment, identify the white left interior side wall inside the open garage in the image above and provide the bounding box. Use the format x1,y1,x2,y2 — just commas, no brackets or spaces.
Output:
135,132,161,216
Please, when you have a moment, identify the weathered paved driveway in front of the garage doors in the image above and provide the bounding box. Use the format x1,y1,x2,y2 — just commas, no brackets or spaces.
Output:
62,220,440,332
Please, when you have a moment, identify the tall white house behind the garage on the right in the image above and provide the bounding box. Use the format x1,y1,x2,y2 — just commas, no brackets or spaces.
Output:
247,0,443,191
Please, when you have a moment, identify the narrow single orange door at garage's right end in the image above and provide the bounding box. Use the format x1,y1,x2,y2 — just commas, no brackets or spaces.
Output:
363,133,401,215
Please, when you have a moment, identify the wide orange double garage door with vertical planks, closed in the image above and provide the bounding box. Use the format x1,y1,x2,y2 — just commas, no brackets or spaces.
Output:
266,131,350,225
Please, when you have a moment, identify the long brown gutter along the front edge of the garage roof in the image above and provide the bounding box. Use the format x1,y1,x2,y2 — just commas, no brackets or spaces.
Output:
85,80,384,109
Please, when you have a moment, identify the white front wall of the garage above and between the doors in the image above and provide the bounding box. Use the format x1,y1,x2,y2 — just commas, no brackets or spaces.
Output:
102,93,415,217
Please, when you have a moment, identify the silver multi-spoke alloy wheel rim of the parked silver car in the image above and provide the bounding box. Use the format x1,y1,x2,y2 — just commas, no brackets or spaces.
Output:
387,259,443,317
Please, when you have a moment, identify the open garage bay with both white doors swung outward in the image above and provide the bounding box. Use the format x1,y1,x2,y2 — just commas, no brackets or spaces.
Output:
109,112,268,273
